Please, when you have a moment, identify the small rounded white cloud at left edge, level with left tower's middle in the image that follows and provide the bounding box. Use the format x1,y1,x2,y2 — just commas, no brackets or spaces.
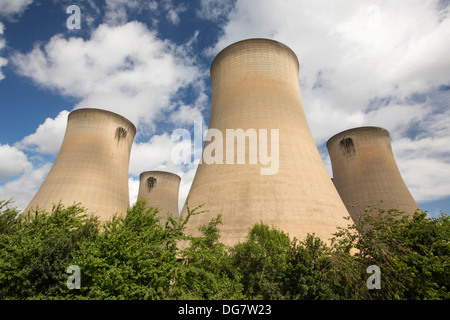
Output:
0,144,32,181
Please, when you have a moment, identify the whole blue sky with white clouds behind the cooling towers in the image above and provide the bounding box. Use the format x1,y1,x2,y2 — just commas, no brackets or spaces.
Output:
0,0,450,216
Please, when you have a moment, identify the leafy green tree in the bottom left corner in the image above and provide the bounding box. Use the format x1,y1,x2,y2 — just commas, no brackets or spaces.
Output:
0,204,99,299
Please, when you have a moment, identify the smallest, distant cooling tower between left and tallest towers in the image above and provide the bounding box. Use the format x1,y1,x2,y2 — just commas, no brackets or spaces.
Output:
138,171,181,218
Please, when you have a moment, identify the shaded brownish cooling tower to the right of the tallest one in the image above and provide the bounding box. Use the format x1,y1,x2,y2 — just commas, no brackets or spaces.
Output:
327,127,419,224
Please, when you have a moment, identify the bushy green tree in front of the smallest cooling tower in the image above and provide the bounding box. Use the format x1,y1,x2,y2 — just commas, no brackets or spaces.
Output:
70,200,190,299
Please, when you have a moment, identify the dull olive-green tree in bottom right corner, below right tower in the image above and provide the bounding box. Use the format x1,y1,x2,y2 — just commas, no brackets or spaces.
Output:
326,207,450,300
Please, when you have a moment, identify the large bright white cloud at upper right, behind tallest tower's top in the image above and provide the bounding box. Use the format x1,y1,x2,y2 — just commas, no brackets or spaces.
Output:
208,0,450,111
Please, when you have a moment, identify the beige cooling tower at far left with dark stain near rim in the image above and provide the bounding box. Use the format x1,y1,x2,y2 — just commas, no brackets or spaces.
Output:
26,109,136,220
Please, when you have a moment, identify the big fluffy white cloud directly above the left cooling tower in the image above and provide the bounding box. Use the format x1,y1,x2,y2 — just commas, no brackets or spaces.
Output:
12,22,201,129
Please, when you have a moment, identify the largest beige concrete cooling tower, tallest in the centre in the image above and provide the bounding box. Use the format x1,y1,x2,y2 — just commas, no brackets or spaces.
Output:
182,39,349,245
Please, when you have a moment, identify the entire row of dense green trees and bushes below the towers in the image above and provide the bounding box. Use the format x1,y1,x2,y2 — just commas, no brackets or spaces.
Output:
0,201,450,300
